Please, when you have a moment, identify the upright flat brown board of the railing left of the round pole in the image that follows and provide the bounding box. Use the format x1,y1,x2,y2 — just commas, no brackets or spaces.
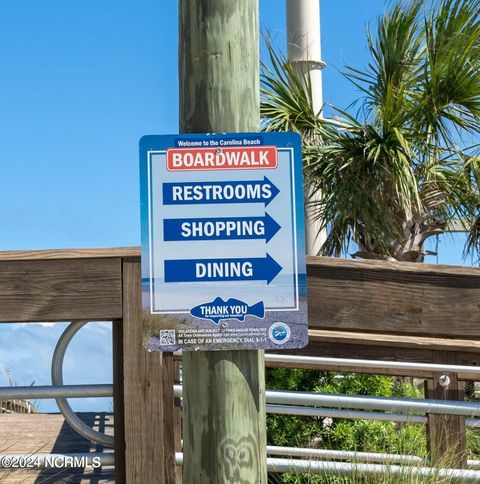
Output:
123,258,165,484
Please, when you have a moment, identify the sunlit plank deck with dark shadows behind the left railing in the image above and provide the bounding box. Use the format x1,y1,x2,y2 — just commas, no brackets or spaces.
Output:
0,413,115,484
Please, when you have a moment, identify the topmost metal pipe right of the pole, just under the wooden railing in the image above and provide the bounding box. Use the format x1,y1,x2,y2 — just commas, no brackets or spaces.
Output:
265,353,480,375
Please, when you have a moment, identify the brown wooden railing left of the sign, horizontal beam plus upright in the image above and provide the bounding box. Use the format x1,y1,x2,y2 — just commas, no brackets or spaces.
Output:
0,247,175,483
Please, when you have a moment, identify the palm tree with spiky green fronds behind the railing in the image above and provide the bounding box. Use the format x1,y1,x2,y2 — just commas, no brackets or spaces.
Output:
261,0,480,261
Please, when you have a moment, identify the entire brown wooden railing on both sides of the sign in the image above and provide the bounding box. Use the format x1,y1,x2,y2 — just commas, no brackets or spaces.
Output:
0,247,480,483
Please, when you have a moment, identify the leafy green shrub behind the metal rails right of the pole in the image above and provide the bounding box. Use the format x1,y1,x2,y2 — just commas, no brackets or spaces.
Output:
266,368,426,484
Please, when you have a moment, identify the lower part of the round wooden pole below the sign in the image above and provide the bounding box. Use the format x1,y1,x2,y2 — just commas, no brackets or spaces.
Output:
183,351,267,484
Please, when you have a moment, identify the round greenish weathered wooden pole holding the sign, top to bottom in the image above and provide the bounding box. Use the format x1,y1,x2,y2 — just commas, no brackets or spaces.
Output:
179,0,267,484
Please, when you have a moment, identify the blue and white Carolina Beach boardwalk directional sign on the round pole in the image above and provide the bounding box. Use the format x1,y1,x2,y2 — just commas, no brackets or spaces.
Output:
140,133,308,351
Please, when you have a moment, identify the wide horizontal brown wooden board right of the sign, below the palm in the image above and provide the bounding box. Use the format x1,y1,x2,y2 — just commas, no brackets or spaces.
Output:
307,257,480,339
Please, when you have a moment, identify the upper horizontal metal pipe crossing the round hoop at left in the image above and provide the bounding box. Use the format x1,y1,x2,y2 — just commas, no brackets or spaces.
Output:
0,384,113,400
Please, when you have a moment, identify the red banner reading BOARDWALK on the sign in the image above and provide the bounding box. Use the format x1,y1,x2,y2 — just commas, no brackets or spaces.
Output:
167,146,278,171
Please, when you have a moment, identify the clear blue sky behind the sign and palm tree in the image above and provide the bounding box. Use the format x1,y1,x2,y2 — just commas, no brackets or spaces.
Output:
0,0,472,410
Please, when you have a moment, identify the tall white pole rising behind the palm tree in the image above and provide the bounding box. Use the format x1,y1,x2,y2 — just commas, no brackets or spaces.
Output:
286,0,326,255
